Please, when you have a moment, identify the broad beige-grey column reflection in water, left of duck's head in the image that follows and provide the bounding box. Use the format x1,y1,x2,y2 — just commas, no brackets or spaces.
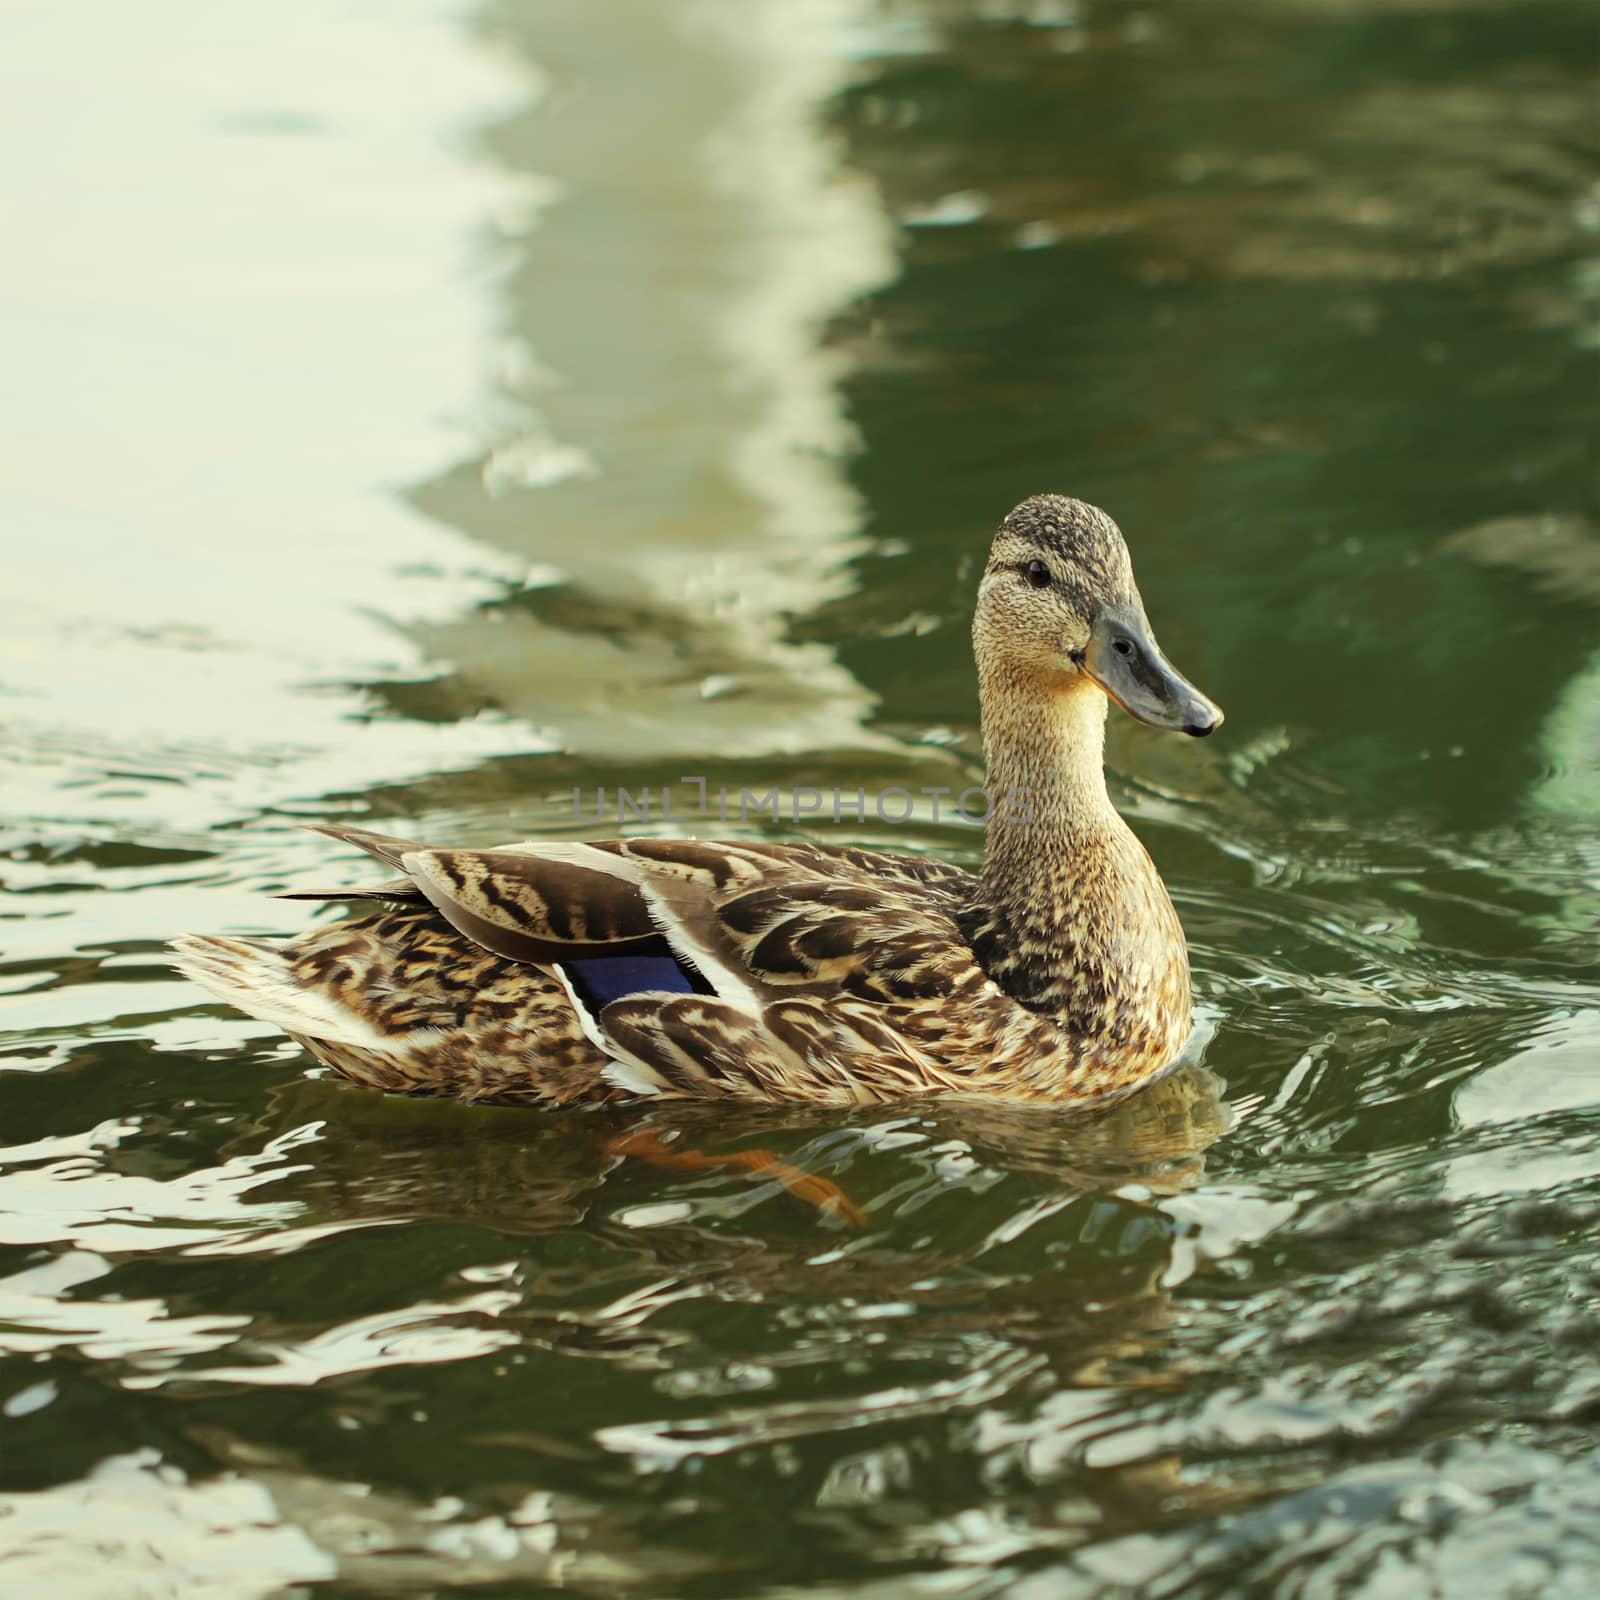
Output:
421,0,894,758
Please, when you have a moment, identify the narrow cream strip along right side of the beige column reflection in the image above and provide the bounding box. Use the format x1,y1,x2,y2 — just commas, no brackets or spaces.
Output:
662,0,894,742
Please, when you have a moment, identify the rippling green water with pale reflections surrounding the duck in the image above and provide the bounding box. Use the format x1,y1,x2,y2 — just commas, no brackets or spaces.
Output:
0,0,1600,1600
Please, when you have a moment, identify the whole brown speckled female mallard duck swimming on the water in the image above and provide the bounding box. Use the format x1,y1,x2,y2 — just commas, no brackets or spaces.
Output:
174,494,1222,1104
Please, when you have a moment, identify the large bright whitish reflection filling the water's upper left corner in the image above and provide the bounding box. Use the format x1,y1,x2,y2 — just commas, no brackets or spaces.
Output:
0,0,544,827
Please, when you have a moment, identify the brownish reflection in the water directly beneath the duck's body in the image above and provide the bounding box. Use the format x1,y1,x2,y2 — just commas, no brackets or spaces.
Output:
240,1066,1232,1235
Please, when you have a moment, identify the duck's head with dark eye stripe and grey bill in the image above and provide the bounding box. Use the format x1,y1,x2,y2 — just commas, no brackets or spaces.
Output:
973,494,1222,738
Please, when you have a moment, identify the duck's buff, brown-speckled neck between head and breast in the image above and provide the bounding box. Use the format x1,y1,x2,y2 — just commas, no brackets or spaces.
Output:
971,662,1147,1014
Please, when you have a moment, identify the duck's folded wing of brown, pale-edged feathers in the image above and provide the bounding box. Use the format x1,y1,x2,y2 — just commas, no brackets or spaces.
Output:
307,835,1036,1104
